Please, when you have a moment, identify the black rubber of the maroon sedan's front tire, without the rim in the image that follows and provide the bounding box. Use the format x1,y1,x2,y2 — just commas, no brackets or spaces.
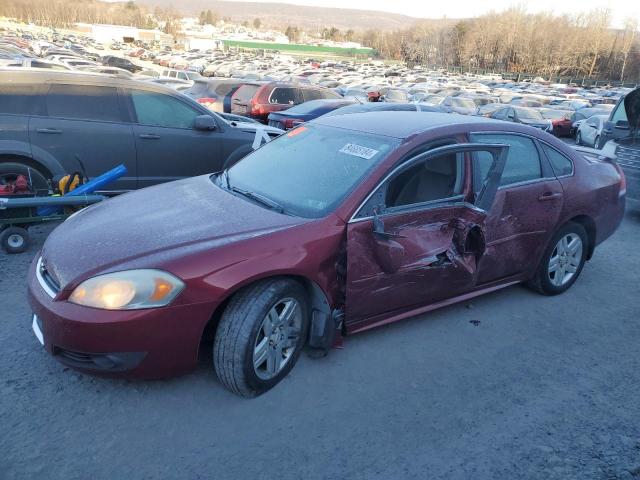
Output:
213,278,310,397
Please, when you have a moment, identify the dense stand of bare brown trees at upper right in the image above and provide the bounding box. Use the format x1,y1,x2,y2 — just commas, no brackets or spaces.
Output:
355,7,640,82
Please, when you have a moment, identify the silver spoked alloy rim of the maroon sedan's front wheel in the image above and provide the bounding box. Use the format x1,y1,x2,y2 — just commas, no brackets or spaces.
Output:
253,298,302,380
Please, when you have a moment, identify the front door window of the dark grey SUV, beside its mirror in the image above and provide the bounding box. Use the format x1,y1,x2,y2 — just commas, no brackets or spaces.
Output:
131,90,200,128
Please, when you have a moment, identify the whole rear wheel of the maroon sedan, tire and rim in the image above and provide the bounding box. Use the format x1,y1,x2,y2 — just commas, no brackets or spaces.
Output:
528,222,589,295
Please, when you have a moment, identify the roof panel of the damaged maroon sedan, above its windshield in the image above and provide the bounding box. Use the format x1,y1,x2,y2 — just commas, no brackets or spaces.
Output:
313,111,500,139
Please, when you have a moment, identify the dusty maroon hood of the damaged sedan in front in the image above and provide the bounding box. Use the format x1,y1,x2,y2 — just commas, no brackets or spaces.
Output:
42,175,309,288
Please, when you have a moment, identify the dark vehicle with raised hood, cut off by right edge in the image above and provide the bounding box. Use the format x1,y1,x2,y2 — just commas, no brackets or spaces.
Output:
600,88,640,207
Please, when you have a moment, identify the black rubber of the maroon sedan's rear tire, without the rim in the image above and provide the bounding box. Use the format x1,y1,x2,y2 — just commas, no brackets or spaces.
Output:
527,222,589,295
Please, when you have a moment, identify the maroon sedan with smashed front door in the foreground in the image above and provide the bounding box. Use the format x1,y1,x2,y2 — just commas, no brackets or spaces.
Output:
29,112,625,396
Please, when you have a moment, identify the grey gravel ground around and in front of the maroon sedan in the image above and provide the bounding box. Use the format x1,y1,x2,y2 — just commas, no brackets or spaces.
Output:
0,214,640,480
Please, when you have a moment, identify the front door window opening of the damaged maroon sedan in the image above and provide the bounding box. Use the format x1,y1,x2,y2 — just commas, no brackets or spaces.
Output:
385,153,464,208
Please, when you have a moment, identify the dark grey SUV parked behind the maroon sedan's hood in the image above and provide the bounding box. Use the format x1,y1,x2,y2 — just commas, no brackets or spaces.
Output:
0,69,281,192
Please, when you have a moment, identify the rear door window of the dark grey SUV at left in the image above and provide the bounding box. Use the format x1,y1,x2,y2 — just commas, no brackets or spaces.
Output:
46,85,124,122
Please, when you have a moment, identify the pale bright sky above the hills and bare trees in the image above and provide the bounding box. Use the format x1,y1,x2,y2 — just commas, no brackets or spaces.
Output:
224,0,640,26
